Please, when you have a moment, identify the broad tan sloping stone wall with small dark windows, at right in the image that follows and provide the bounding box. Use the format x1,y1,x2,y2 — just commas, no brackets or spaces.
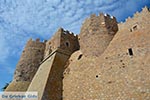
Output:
63,6,150,100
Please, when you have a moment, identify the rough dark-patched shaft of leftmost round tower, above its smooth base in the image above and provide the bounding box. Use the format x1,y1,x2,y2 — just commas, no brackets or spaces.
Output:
14,39,45,82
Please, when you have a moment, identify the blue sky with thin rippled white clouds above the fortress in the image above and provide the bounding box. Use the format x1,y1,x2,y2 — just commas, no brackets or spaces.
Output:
0,0,150,89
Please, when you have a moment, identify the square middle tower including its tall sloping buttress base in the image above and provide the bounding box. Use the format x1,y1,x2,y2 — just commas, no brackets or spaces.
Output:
28,28,80,100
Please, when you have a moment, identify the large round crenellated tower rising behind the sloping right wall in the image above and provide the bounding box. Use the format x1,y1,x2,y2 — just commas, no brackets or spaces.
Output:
79,13,118,56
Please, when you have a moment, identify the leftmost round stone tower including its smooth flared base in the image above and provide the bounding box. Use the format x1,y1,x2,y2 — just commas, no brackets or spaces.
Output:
6,39,45,91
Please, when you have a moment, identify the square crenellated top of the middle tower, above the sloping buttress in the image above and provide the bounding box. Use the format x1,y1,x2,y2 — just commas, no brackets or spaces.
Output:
44,28,79,58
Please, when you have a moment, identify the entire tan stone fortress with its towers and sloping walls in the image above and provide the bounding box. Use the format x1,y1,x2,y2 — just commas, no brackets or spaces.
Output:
6,7,150,100
